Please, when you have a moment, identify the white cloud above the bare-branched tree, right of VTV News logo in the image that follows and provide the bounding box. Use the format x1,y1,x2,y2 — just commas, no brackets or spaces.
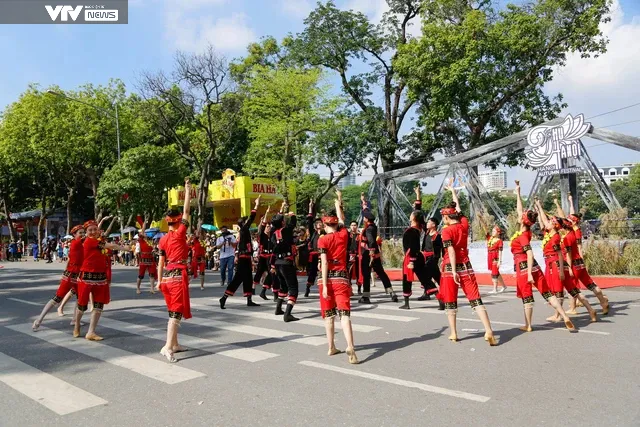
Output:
166,10,256,53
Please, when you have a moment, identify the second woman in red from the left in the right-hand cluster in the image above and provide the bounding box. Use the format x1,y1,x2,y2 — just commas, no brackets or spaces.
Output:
536,199,598,322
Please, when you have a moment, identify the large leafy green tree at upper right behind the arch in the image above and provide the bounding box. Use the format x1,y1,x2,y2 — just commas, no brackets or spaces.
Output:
393,0,610,164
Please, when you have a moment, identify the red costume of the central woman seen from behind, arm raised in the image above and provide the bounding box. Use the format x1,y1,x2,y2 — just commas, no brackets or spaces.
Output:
318,225,352,318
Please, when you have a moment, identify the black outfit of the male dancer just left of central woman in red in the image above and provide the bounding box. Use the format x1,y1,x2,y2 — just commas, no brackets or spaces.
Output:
271,215,298,304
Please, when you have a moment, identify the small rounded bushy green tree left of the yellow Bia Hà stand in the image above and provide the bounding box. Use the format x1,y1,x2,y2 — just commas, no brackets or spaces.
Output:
98,145,188,229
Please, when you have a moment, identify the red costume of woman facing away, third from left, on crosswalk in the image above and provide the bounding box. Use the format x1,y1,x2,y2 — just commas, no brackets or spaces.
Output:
158,219,191,320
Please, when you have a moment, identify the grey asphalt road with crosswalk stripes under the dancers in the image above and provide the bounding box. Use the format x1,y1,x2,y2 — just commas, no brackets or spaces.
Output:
0,262,640,427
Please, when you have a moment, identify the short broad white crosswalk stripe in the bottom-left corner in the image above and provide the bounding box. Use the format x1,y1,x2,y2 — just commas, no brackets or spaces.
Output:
0,353,109,415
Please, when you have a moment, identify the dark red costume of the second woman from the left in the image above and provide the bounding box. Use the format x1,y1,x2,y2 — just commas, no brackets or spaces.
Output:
78,237,111,312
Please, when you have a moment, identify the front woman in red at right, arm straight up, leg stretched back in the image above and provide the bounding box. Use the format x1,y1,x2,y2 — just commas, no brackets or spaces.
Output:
511,181,575,332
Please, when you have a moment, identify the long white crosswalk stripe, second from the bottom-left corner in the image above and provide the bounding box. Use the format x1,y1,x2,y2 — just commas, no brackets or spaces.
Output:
7,324,206,384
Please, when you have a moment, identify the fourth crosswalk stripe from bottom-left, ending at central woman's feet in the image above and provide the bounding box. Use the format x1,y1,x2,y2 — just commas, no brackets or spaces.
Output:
125,309,327,346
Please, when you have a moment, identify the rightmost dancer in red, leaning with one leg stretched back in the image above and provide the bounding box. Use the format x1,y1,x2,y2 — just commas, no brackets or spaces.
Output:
555,199,609,316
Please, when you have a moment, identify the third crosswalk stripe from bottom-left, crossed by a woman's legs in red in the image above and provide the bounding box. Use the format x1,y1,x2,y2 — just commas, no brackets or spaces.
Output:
100,317,279,362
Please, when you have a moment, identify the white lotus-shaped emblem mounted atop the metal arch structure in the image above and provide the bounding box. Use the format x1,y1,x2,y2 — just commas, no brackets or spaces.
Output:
526,114,591,175
